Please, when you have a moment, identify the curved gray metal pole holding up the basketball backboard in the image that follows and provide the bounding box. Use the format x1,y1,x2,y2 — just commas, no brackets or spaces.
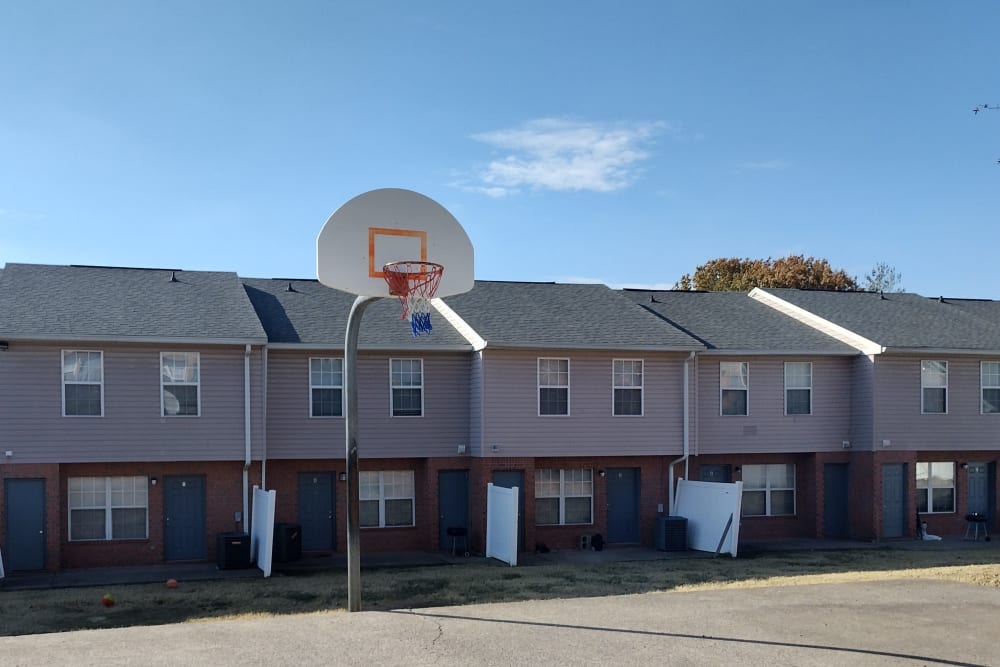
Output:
344,296,381,611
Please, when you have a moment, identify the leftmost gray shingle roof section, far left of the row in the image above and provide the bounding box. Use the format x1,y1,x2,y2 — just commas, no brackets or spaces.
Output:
0,264,265,343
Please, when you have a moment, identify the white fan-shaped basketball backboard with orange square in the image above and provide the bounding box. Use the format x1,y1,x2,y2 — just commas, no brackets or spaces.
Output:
316,188,474,297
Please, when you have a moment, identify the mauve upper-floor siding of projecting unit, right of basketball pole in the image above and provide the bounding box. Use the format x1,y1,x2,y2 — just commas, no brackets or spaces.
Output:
483,348,684,457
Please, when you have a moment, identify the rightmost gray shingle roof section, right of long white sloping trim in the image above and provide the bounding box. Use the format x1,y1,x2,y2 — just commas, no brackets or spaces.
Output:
764,289,1000,350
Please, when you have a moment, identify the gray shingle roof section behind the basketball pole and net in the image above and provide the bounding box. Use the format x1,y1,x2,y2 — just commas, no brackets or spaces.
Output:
243,278,472,350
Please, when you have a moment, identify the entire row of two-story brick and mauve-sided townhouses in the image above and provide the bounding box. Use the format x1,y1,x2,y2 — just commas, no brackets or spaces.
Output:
0,264,1000,571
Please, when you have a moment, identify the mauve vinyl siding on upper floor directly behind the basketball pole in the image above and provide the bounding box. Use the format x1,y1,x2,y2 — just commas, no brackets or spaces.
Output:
267,350,470,459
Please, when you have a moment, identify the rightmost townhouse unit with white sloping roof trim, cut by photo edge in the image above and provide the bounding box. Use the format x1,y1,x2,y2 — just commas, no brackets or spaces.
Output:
749,289,1000,538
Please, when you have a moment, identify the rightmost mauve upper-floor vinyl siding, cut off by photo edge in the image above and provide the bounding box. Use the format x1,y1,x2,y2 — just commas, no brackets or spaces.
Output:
875,354,1000,451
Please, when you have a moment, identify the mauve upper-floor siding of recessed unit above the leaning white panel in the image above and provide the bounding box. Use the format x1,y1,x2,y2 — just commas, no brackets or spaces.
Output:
696,356,851,455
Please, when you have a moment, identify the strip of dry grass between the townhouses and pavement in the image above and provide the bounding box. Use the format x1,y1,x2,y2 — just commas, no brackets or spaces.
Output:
0,549,1000,635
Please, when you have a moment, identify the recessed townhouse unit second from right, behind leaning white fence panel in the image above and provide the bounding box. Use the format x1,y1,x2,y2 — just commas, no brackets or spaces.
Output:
626,290,861,539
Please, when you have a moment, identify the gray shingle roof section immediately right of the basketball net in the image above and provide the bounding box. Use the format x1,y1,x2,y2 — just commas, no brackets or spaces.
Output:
444,280,704,350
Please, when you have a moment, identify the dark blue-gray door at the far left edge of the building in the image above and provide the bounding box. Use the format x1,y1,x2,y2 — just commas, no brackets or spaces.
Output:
3,478,45,572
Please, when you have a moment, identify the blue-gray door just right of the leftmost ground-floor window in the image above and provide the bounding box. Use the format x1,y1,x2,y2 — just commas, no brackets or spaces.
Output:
163,475,206,560
